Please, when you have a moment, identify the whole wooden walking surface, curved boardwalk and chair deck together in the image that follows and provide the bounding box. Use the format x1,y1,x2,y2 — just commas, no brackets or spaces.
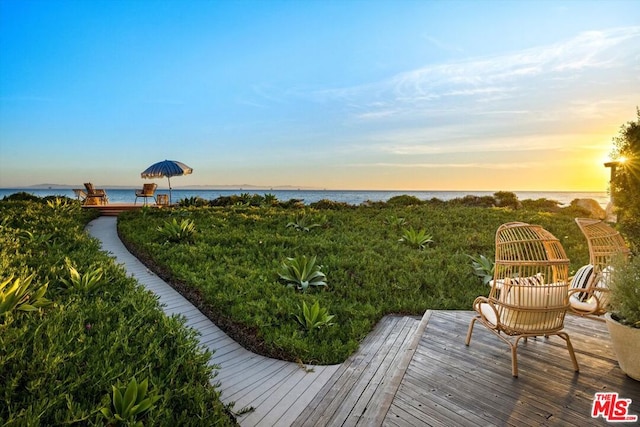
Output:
87,217,640,427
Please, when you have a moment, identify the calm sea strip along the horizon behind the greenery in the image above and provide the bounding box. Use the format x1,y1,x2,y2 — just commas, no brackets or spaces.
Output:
0,188,609,207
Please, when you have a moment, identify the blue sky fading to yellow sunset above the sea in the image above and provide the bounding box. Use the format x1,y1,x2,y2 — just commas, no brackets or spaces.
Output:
0,0,640,191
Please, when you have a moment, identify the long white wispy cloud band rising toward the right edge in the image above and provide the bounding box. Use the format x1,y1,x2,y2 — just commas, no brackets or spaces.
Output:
312,26,640,120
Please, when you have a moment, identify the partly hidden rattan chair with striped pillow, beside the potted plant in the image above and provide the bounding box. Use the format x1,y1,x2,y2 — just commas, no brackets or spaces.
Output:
569,218,630,321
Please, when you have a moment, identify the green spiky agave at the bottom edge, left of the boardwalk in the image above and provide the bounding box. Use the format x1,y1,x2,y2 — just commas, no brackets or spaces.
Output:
100,378,162,427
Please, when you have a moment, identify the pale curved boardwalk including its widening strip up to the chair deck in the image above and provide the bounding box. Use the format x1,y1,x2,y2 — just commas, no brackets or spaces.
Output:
87,216,426,426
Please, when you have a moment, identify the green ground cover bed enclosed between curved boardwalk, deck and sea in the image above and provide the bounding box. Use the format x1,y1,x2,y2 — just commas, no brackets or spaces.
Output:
118,194,588,364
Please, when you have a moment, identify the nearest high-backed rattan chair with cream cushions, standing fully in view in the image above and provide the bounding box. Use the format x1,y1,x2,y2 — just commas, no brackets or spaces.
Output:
466,222,579,377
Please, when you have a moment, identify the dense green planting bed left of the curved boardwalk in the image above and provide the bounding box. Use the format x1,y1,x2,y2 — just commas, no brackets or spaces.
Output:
0,199,235,426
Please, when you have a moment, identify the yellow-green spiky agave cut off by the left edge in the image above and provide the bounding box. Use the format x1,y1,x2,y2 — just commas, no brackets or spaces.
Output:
0,273,51,317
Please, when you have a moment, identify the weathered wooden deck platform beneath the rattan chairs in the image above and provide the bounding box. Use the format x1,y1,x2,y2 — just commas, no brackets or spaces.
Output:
383,311,640,426
